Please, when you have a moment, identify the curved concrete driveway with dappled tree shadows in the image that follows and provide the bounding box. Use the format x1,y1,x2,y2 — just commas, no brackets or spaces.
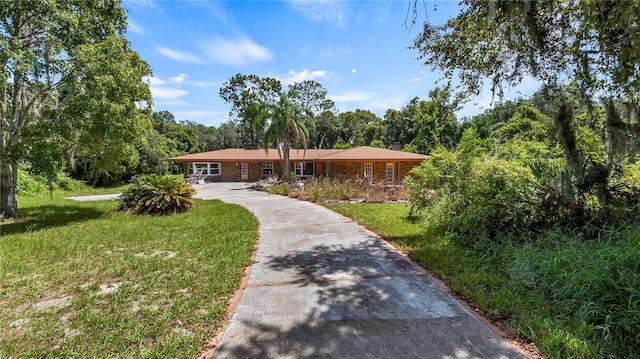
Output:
196,183,523,359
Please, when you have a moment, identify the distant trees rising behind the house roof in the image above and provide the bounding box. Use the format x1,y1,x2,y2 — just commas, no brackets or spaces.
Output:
220,74,459,153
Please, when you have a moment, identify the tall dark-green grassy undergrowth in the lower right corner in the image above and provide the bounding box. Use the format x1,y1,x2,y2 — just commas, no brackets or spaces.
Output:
507,229,640,358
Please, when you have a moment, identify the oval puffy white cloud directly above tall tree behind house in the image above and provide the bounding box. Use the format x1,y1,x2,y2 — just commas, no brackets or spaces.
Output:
202,36,273,67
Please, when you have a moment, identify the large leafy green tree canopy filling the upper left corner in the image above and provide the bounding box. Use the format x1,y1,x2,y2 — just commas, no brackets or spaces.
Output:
0,0,151,217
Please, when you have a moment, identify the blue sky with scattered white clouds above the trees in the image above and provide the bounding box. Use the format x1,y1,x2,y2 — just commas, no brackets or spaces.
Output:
123,0,536,126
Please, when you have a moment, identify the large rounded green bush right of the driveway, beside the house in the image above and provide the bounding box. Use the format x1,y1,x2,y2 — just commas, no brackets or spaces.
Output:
405,150,539,243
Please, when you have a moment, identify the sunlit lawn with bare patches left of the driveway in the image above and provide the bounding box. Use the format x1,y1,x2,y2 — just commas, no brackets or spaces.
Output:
0,197,258,358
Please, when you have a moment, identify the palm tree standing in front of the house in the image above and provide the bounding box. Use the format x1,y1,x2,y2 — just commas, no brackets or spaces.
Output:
262,90,307,180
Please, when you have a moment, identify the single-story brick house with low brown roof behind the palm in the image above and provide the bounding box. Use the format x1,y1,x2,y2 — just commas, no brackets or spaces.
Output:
169,146,428,184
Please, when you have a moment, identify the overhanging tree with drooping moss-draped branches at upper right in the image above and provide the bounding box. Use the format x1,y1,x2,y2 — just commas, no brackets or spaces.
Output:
414,0,640,211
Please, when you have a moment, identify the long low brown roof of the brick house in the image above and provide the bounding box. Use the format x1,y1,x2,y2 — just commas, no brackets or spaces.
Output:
169,146,428,162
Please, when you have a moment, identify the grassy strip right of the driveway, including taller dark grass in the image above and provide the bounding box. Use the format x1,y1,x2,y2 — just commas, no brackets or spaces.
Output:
325,203,640,358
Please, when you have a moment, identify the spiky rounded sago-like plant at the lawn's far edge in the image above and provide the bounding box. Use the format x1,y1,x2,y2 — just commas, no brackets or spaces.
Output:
118,175,196,215
